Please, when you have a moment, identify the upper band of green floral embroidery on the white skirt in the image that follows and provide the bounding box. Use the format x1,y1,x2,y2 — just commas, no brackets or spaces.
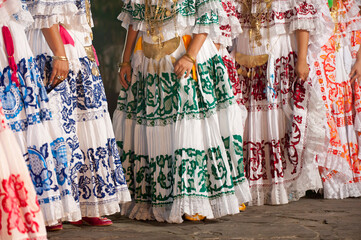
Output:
118,55,236,126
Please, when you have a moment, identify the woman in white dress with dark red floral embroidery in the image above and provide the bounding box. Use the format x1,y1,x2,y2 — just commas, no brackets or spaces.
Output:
233,0,332,205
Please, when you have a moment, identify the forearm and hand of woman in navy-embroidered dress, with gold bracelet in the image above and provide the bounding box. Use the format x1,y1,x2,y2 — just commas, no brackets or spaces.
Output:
41,24,69,87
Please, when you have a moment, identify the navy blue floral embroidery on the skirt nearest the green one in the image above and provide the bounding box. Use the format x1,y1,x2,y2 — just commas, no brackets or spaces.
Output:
36,52,126,202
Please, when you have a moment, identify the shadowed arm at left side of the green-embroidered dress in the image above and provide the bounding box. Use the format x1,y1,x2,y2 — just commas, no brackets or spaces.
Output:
119,25,138,89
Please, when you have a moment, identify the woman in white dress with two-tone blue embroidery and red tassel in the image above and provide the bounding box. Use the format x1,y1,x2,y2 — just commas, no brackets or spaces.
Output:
0,1,78,231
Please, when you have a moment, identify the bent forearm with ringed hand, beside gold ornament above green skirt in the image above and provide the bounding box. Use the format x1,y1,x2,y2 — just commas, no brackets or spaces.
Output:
174,33,208,78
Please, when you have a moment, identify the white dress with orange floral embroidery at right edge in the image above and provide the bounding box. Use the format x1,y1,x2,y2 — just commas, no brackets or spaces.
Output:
314,0,361,198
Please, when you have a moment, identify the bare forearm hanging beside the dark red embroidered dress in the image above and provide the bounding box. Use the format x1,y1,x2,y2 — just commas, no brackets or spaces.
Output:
295,30,310,81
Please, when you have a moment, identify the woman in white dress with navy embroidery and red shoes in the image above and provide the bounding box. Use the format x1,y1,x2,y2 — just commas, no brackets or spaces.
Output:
23,0,130,229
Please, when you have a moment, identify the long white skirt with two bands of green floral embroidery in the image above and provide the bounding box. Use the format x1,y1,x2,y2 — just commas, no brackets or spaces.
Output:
113,33,250,223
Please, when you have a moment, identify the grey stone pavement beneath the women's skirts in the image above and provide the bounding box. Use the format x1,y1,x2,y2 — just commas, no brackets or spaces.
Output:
48,198,361,240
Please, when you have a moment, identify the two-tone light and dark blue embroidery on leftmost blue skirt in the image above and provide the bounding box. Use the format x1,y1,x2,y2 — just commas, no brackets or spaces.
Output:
0,55,71,209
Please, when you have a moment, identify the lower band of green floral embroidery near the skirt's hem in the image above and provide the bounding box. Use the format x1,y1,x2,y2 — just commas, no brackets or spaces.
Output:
118,140,244,205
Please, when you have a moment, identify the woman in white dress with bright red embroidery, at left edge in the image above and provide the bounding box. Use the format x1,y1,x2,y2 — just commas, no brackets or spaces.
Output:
0,0,46,240
